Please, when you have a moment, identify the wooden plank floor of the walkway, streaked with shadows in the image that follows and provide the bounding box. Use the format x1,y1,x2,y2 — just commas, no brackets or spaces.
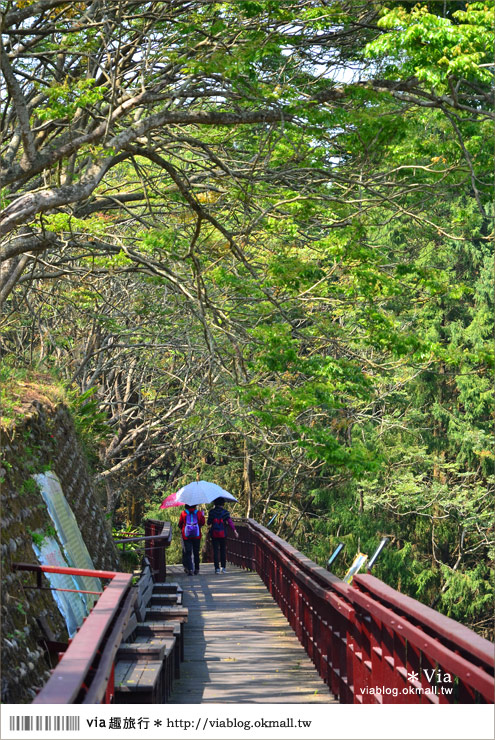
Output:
167,563,335,704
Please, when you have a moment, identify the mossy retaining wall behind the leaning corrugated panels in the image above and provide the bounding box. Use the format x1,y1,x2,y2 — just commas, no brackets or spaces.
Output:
0,398,122,703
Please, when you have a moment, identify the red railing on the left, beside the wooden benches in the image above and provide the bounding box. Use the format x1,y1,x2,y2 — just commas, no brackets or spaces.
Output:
14,563,136,704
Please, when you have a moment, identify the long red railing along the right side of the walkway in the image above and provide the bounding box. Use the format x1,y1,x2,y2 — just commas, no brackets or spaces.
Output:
228,519,494,704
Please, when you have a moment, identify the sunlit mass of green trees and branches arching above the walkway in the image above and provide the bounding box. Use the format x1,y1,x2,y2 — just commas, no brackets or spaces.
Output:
0,0,494,634
